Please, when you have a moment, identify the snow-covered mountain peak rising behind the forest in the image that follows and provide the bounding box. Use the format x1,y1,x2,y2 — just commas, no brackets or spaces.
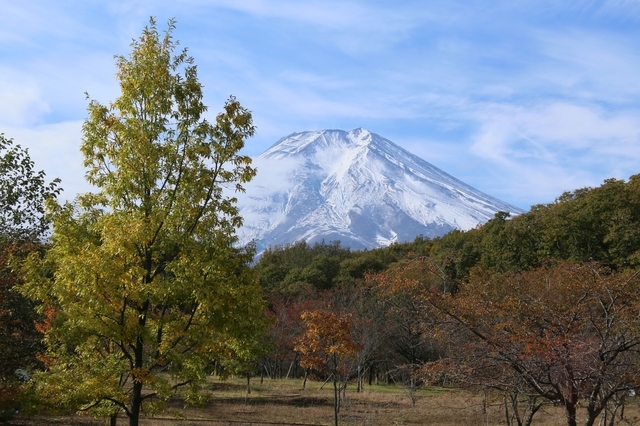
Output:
238,128,521,252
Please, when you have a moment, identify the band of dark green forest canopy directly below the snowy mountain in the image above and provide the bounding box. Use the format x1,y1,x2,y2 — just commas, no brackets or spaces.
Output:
255,171,640,296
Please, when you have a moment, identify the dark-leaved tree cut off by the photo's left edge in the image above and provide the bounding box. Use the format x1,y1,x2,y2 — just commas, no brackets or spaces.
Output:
0,134,60,417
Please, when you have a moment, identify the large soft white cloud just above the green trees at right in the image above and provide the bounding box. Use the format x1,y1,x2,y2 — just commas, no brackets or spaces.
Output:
470,103,640,202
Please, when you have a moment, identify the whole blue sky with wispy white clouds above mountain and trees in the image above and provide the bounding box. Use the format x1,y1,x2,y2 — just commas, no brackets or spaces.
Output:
0,0,640,209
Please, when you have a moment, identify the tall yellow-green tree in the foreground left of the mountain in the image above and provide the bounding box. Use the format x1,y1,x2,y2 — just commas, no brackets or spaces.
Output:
23,19,264,426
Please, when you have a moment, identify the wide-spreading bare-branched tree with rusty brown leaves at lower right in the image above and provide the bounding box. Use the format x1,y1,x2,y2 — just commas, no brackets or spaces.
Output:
425,262,640,426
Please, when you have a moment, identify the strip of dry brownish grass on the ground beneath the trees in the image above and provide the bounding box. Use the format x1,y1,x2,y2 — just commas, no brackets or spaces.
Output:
12,380,640,426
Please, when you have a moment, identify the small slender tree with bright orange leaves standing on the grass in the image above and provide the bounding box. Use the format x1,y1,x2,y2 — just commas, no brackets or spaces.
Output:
295,309,360,426
